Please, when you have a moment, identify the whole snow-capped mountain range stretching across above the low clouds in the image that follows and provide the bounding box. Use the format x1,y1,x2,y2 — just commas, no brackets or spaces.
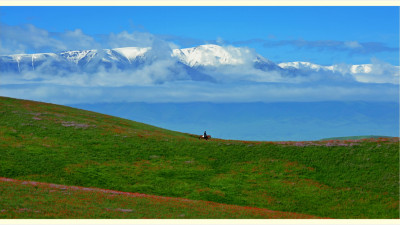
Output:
0,44,399,83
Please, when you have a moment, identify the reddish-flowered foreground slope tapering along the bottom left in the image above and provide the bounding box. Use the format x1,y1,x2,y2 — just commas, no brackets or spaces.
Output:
0,178,318,219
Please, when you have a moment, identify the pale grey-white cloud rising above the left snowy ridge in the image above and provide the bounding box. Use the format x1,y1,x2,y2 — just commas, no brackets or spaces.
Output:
0,23,177,55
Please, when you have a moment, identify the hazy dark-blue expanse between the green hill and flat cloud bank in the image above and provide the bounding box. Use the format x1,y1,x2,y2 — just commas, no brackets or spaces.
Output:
70,102,399,141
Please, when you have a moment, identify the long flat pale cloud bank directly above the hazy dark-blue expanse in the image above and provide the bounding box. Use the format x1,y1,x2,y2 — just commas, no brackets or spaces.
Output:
0,81,399,104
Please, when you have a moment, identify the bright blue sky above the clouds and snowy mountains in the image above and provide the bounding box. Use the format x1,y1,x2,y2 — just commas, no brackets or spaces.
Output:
0,6,399,65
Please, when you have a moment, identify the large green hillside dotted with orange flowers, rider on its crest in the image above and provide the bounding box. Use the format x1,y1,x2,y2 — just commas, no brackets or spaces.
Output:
0,98,399,218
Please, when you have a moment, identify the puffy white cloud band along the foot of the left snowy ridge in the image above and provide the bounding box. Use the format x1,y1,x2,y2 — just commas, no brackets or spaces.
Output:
1,60,189,87
